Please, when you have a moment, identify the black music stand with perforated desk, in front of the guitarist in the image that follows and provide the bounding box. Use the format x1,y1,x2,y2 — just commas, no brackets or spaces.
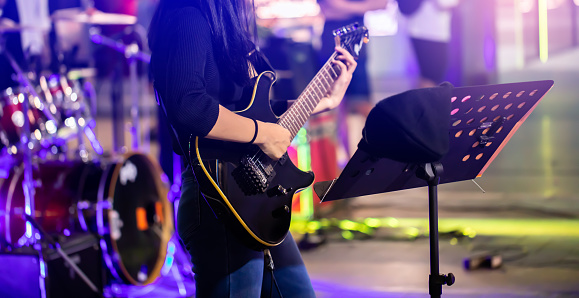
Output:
314,81,553,297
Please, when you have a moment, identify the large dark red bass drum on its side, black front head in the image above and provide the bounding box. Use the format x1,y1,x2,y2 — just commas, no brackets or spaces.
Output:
0,153,173,285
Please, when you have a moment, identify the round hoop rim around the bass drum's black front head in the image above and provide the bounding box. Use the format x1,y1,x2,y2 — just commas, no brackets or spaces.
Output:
102,152,173,285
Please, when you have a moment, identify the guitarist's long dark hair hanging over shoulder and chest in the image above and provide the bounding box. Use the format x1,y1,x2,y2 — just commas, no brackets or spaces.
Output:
148,0,257,84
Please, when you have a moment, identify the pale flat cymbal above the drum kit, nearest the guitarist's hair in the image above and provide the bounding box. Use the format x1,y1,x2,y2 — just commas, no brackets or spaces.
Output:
52,8,137,25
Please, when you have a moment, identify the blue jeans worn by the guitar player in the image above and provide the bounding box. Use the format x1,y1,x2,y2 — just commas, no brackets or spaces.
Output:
177,168,315,298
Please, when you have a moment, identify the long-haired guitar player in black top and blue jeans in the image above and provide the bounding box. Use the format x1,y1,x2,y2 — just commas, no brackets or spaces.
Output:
149,0,357,297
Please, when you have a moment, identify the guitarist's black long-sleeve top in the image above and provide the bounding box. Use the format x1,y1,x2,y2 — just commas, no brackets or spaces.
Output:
151,7,242,153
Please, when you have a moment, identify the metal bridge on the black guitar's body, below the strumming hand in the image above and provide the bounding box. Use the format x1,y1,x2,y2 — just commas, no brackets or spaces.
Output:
231,155,271,196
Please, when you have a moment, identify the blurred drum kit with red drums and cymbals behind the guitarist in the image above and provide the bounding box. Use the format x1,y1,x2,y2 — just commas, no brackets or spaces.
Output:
0,5,186,291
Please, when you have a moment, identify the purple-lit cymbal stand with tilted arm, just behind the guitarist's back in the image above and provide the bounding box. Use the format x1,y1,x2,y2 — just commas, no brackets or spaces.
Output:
89,27,151,151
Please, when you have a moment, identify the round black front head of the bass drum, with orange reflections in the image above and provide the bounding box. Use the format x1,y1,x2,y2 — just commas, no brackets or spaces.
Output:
97,153,173,285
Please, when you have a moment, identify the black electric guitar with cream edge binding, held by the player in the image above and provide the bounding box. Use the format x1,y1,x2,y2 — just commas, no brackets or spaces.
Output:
189,24,368,249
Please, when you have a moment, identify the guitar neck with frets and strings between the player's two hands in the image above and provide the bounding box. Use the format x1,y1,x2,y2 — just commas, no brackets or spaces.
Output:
277,52,341,139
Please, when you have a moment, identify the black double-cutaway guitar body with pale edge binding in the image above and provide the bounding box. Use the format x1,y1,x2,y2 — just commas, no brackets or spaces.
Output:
191,72,314,250
